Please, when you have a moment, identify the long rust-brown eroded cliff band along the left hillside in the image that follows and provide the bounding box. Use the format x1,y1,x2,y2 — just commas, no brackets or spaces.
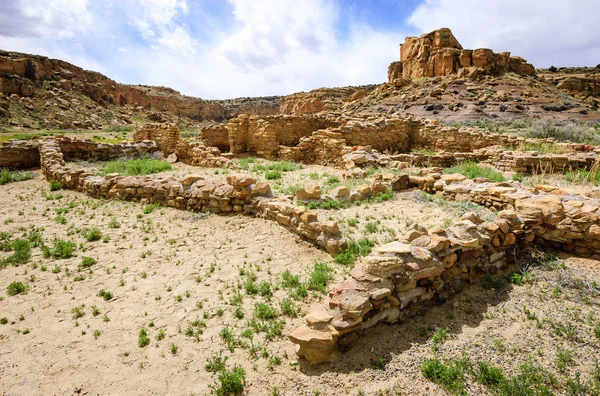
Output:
0,51,227,120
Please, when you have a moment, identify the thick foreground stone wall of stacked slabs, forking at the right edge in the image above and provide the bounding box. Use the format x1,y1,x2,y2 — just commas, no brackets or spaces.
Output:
289,173,600,364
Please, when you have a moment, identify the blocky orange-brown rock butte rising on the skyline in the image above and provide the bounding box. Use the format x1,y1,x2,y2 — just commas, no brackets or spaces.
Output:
388,28,535,85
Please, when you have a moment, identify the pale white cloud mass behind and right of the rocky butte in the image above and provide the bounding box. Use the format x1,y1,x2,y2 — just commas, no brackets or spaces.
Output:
409,0,600,67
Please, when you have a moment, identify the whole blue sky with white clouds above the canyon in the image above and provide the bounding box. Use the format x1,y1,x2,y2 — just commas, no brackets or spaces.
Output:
0,0,600,99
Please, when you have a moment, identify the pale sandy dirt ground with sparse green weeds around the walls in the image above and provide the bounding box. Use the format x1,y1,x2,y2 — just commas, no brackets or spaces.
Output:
0,171,600,395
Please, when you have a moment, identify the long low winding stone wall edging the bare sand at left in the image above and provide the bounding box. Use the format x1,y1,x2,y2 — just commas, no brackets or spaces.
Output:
39,139,347,254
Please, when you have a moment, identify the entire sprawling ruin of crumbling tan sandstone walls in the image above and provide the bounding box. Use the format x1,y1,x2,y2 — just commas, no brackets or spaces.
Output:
0,115,600,364
